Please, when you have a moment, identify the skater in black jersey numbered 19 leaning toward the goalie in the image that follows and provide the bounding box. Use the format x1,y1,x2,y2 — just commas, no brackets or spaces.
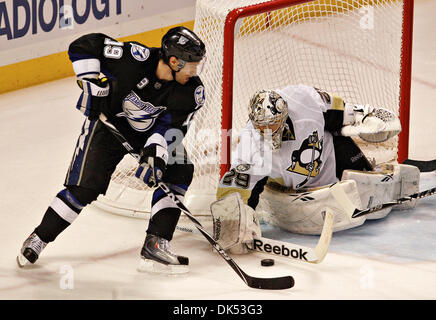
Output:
17,27,206,273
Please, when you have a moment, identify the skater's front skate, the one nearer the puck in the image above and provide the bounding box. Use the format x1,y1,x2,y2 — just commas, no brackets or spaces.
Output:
138,234,189,274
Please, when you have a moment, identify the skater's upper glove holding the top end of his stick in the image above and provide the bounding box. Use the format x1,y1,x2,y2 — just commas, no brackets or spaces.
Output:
76,77,110,120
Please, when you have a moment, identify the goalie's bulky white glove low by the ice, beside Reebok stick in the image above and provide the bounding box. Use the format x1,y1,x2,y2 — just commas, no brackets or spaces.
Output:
210,192,261,254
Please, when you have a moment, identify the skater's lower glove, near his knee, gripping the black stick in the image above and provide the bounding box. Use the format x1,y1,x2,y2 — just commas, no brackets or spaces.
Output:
135,144,168,188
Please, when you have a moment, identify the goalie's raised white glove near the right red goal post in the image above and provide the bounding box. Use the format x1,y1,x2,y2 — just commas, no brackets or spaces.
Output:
342,103,401,142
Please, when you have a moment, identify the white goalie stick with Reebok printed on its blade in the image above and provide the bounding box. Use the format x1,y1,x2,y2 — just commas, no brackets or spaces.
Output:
176,208,334,264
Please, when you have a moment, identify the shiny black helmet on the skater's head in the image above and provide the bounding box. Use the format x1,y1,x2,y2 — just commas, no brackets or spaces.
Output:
161,27,206,63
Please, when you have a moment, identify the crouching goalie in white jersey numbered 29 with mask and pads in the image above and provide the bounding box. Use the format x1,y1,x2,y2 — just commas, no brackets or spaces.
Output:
211,85,419,253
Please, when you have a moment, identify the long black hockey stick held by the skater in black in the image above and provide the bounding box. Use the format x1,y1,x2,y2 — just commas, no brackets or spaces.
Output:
100,113,295,290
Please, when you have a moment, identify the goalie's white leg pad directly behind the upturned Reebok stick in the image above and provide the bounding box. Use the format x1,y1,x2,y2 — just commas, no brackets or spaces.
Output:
256,180,366,235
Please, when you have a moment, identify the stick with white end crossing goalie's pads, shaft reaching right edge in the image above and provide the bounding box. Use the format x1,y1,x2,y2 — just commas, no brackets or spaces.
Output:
331,183,436,218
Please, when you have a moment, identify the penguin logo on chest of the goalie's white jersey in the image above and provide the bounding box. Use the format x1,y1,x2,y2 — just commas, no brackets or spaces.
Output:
286,131,323,177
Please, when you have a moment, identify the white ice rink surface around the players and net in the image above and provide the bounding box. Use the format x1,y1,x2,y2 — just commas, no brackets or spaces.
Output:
0,0,436,300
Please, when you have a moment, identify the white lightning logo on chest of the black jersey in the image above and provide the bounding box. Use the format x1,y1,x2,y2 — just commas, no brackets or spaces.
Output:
117,91,166,132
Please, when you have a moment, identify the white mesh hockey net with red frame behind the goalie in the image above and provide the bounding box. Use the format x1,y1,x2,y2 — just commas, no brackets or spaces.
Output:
95,0,411,217
